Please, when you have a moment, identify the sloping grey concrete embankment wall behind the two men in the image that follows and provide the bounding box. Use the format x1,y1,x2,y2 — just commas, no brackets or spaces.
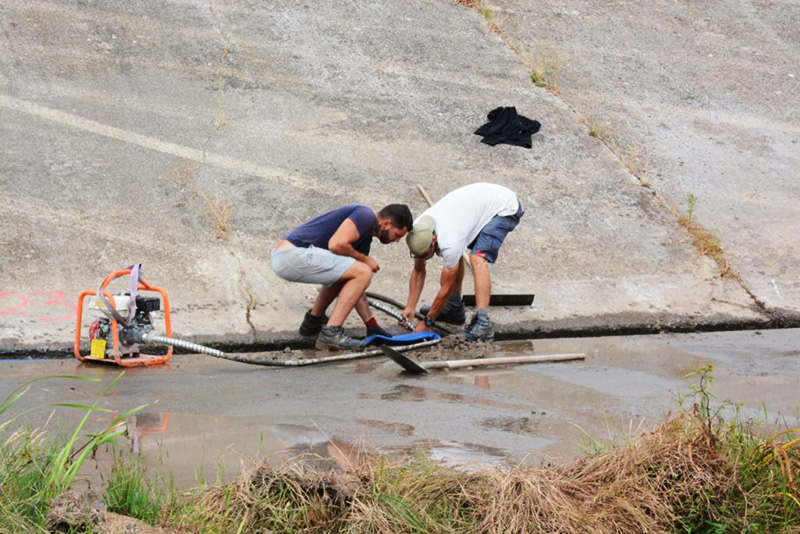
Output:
0,0,800,354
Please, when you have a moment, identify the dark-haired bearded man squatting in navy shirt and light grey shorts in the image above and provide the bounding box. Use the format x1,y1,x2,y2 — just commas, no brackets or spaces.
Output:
271,204,413,349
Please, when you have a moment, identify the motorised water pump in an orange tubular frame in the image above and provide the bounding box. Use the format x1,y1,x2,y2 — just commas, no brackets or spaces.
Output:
74,264,172,367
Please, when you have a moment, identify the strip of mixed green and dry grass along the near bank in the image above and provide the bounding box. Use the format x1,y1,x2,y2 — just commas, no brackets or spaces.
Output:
0,367,800,533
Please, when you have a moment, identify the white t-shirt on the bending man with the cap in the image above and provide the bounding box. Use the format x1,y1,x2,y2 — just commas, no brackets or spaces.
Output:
420,182,519,267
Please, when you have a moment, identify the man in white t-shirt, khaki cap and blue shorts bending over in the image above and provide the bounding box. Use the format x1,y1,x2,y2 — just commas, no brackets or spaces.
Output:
403,182,525,341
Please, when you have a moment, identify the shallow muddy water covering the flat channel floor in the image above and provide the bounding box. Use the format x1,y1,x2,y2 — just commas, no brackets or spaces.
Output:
0,330,800,487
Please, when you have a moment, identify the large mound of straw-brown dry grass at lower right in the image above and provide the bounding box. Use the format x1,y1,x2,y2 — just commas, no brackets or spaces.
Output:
462,417,733,533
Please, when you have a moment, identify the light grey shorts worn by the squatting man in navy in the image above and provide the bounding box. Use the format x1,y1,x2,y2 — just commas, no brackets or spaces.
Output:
270,247,356,286
